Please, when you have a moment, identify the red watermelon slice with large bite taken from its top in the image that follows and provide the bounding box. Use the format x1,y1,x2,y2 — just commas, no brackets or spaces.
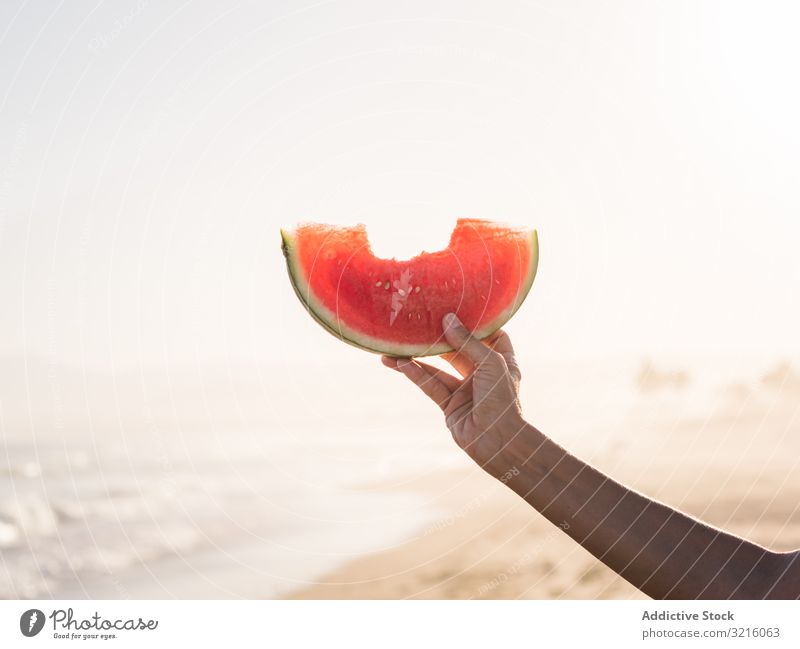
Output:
281,219,539,356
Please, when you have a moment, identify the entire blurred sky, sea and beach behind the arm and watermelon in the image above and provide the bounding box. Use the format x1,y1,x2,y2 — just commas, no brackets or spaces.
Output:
0,0,800,598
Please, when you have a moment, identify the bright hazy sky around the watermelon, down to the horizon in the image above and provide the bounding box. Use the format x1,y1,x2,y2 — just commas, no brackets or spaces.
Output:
0,0,800,367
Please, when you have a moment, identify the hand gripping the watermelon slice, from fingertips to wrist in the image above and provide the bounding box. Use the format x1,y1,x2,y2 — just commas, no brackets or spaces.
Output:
381,313,526,469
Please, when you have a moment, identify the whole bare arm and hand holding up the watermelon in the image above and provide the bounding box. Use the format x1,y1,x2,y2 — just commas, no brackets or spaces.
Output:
382,314,800,599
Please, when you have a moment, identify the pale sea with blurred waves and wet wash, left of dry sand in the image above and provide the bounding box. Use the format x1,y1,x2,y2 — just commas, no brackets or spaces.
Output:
0,420,461,598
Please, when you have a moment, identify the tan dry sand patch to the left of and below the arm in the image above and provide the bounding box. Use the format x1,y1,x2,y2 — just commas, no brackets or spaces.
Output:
294,471,641,599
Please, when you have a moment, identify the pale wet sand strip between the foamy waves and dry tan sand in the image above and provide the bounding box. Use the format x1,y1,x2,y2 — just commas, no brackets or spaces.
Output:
47,474,454,599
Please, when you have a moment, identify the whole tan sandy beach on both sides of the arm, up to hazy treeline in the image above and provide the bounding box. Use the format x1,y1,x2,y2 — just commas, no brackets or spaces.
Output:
294,370,800,599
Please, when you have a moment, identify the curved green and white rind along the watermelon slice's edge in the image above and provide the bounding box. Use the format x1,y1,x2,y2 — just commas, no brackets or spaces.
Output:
281,228,539,358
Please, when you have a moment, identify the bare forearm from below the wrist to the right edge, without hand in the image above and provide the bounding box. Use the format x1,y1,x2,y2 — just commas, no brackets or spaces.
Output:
484,426,788,599
